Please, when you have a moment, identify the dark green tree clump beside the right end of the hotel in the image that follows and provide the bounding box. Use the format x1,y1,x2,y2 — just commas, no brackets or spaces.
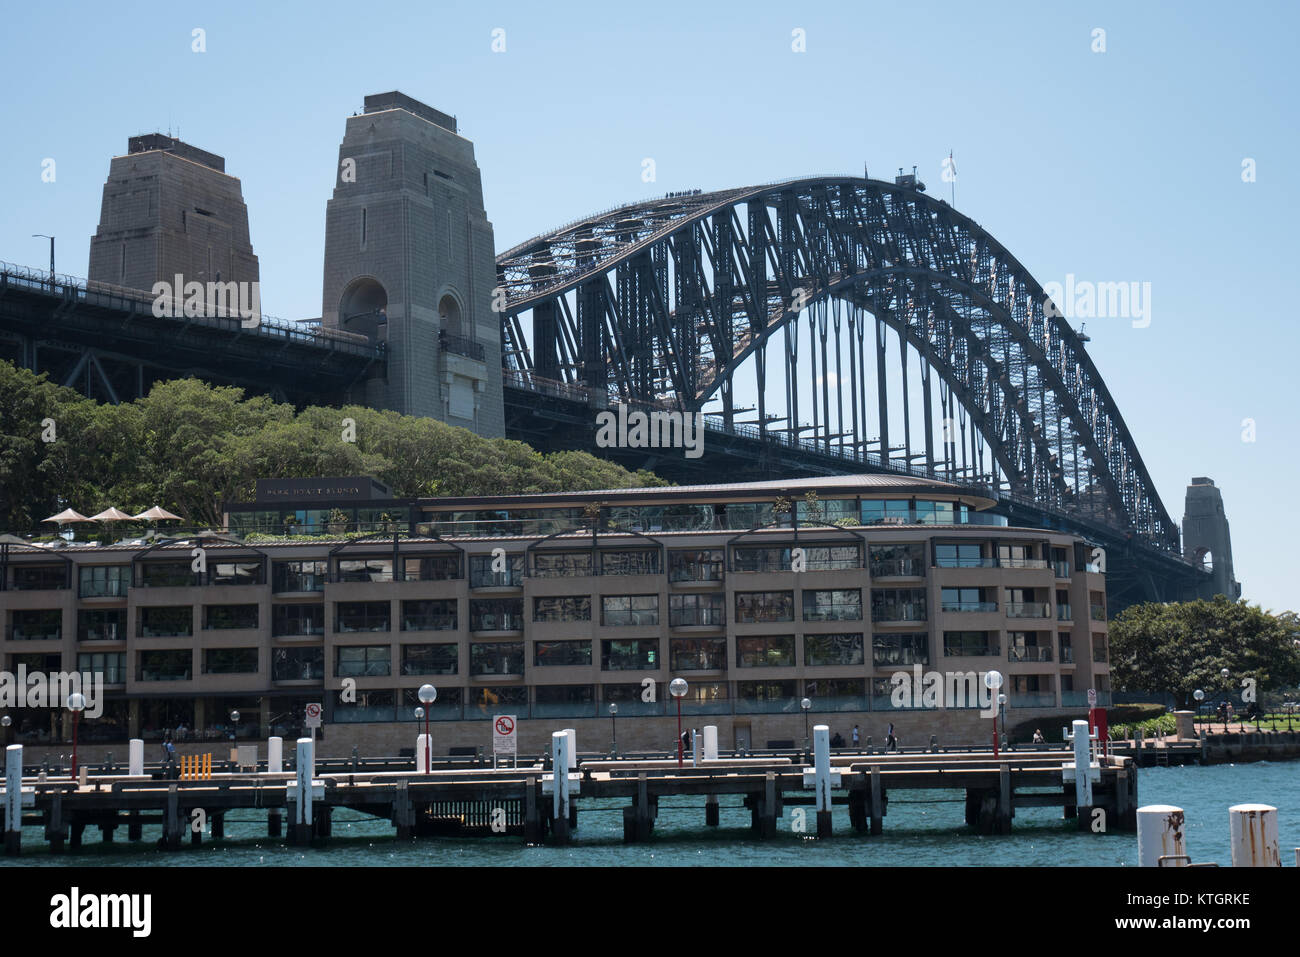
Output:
1110,596,1300,707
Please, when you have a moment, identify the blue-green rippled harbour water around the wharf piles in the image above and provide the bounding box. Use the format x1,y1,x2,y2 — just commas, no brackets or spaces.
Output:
0,762,1300,867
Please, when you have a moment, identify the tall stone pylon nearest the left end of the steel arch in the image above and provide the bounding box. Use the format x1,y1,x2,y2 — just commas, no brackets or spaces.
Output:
321,91,506,436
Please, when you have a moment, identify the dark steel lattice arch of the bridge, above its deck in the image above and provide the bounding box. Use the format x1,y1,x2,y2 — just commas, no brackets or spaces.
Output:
497,177,1179,554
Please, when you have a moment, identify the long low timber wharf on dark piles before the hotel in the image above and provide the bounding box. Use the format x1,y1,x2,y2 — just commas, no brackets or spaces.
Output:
7,750,1138,853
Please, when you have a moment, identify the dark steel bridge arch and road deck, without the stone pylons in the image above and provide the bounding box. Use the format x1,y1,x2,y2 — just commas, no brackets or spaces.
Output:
0,100,1235,610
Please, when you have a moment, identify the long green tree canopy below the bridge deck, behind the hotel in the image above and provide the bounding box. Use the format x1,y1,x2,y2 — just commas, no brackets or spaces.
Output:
0,361,667,532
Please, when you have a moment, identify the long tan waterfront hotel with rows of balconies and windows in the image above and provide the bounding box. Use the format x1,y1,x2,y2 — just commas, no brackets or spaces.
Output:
0,475,1109,755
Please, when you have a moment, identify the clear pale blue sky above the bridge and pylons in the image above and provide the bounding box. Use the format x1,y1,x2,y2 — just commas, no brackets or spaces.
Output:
0,0,1300,610
